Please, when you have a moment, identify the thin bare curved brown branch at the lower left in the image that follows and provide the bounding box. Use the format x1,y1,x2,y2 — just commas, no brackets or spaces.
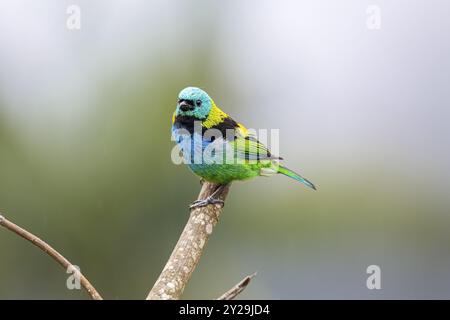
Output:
0,214,103,300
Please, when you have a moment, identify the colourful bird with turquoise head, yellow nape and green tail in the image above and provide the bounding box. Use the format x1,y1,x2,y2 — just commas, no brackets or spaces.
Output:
172,87,316,209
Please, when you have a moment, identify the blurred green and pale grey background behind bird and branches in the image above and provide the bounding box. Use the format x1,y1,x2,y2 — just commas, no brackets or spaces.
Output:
0,0,450,299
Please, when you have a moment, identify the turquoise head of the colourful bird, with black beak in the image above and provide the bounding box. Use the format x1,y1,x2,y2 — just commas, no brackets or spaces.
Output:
175,87,213,120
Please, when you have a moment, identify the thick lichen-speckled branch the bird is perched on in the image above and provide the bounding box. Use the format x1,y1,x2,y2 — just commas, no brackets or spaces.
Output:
147,182,229,300
